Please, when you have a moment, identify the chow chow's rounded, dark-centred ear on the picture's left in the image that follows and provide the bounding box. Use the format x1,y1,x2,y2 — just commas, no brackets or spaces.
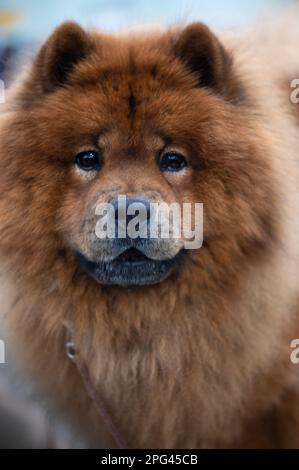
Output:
32,22,93,93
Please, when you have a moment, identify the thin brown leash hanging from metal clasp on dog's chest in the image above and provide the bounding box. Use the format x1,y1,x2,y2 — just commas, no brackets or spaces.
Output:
66,340,129,450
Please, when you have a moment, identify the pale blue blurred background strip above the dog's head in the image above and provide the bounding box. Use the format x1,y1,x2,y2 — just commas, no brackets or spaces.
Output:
0,0,291,78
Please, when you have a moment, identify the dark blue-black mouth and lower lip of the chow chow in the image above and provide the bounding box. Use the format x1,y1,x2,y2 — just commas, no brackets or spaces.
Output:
77,248,184,286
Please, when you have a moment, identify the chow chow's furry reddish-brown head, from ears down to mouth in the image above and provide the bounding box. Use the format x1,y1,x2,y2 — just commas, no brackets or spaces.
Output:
0,23,272,285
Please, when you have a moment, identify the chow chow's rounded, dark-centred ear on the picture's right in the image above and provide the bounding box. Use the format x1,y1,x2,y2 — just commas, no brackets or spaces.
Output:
175,23,231,92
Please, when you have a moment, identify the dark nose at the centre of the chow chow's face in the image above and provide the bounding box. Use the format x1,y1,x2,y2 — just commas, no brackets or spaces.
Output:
111,197,151,226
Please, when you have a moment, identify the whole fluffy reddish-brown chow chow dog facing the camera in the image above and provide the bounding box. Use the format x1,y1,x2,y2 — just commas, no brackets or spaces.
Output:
0,12,299,448
